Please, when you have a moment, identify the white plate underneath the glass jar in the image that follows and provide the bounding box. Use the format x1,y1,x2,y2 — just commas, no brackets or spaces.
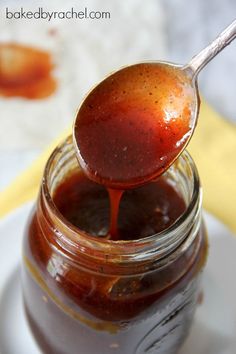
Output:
0,204,236,354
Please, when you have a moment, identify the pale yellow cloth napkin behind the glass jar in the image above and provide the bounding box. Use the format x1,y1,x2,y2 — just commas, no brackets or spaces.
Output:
0,102,236,232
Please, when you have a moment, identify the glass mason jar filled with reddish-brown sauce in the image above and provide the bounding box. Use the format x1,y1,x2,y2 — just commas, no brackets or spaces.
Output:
23,137,207,354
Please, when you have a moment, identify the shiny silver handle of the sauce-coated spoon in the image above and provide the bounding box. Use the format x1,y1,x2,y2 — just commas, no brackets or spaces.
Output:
185,20,236,76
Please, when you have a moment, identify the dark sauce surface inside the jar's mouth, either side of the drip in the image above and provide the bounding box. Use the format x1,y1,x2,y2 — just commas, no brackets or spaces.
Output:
53,171,186,240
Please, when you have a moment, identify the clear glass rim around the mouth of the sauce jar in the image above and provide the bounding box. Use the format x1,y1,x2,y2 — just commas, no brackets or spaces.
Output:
41,135,202,261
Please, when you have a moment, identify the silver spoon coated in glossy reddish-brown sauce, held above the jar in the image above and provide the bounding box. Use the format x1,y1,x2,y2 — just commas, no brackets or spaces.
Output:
73,20,236,189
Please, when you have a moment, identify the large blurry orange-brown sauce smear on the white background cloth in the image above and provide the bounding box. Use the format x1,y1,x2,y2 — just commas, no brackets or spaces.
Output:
0,43,57,99
